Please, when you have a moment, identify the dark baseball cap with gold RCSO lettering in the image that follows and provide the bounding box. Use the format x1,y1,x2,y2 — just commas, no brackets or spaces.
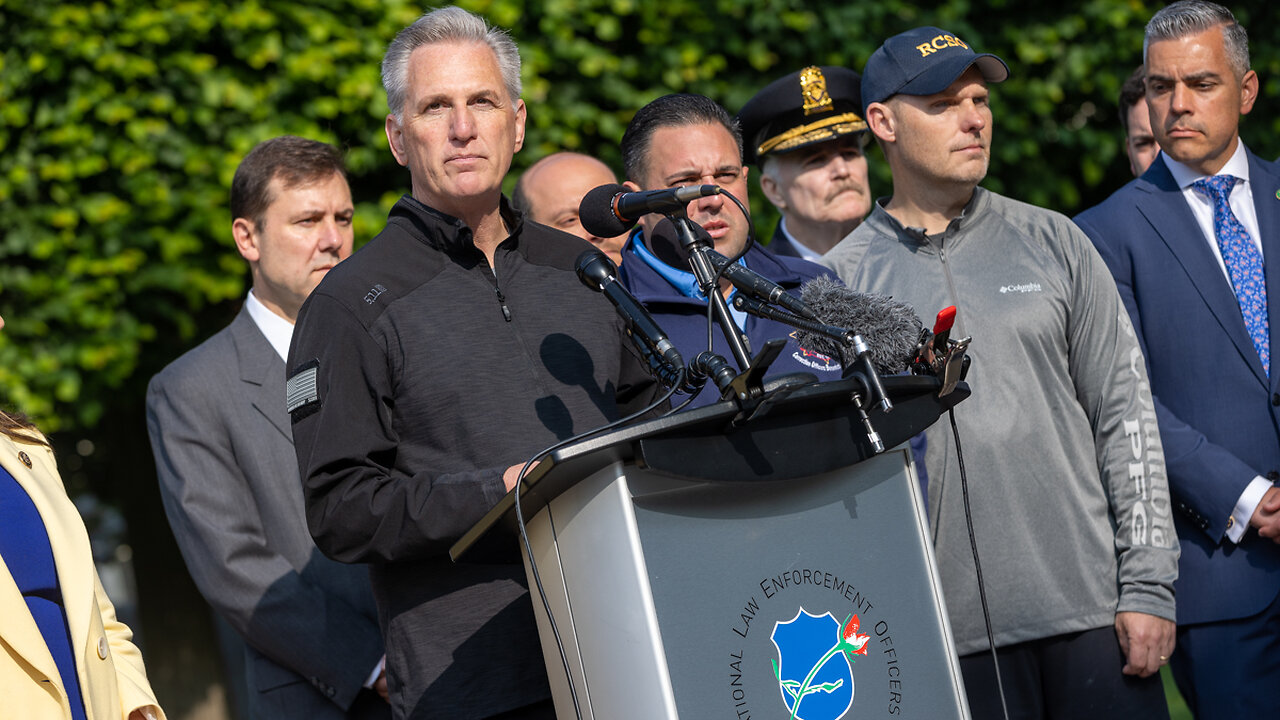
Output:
863,27,1009,110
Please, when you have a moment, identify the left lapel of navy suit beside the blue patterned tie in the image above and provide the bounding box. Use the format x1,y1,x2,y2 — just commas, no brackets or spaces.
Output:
1138,155,1271,386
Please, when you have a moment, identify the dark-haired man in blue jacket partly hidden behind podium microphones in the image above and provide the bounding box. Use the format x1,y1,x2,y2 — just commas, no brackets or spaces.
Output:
618,95,841,406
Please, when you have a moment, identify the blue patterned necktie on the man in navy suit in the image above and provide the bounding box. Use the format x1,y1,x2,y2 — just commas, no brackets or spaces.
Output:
1192,176,1271,377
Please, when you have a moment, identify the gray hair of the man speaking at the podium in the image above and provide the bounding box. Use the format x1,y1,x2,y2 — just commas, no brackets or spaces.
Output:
383,5,520,120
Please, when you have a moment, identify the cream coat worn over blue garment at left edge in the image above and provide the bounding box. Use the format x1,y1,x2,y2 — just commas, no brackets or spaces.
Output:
0,311,164,720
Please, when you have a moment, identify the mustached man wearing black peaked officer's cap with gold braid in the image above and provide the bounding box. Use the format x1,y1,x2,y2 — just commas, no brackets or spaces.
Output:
737,65,872,260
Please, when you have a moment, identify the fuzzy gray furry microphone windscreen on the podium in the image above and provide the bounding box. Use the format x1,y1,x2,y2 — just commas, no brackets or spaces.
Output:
796,275,924,375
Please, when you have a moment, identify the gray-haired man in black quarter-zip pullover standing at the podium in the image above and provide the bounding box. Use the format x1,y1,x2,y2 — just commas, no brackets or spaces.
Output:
288,8,655,720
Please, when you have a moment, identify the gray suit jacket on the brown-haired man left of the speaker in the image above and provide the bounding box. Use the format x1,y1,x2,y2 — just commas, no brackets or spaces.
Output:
147,309,390,719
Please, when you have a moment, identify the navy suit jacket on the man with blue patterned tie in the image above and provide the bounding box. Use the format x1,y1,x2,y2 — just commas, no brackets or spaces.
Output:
1075,152,1280,624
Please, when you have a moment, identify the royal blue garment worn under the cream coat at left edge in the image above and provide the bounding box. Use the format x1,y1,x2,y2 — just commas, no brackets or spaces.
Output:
0,468,84,720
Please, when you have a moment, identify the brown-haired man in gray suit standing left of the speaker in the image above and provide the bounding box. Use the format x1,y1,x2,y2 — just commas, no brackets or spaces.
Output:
147,137,390,720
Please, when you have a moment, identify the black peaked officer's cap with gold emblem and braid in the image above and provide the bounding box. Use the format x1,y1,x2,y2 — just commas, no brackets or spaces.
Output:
737,65,867,163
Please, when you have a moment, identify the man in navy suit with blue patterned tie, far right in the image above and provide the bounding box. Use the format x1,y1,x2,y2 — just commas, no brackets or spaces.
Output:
1075,0,1280,719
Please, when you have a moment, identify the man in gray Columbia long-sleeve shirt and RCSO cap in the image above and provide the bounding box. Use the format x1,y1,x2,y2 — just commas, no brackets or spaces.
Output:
823,27,1179,720
